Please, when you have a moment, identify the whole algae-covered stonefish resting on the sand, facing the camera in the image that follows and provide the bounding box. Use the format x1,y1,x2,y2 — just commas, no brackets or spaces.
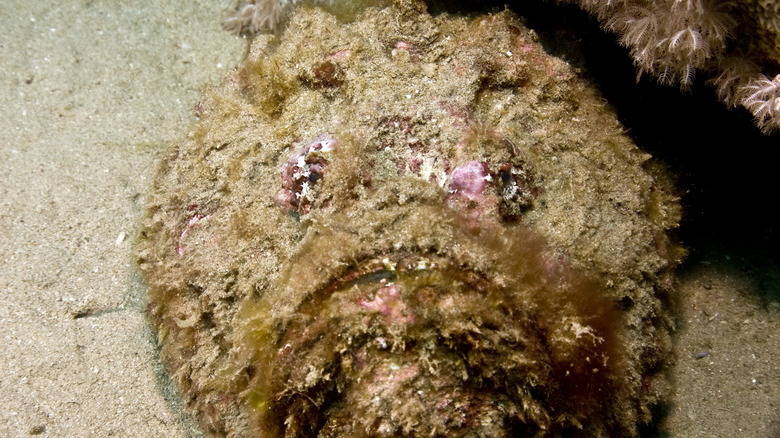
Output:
138,1,679,437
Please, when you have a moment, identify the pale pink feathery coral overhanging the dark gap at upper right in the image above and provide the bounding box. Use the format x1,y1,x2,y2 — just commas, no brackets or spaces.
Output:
561,0,780,133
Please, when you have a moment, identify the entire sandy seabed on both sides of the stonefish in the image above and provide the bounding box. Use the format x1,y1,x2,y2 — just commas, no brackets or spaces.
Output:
0,0,780,437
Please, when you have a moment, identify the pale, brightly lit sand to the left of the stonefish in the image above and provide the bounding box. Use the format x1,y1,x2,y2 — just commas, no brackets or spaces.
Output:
0,0,247,437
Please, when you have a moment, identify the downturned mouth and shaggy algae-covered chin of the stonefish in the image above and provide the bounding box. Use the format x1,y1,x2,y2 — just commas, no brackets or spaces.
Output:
242,241,622,437
